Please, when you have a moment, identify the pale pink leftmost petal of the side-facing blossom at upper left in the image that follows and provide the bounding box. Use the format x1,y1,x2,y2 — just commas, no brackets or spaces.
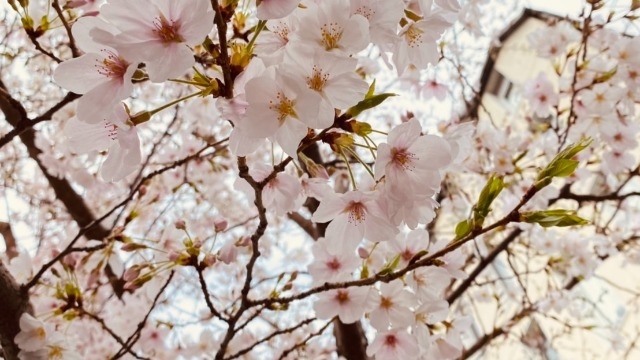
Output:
53,54,109,94
